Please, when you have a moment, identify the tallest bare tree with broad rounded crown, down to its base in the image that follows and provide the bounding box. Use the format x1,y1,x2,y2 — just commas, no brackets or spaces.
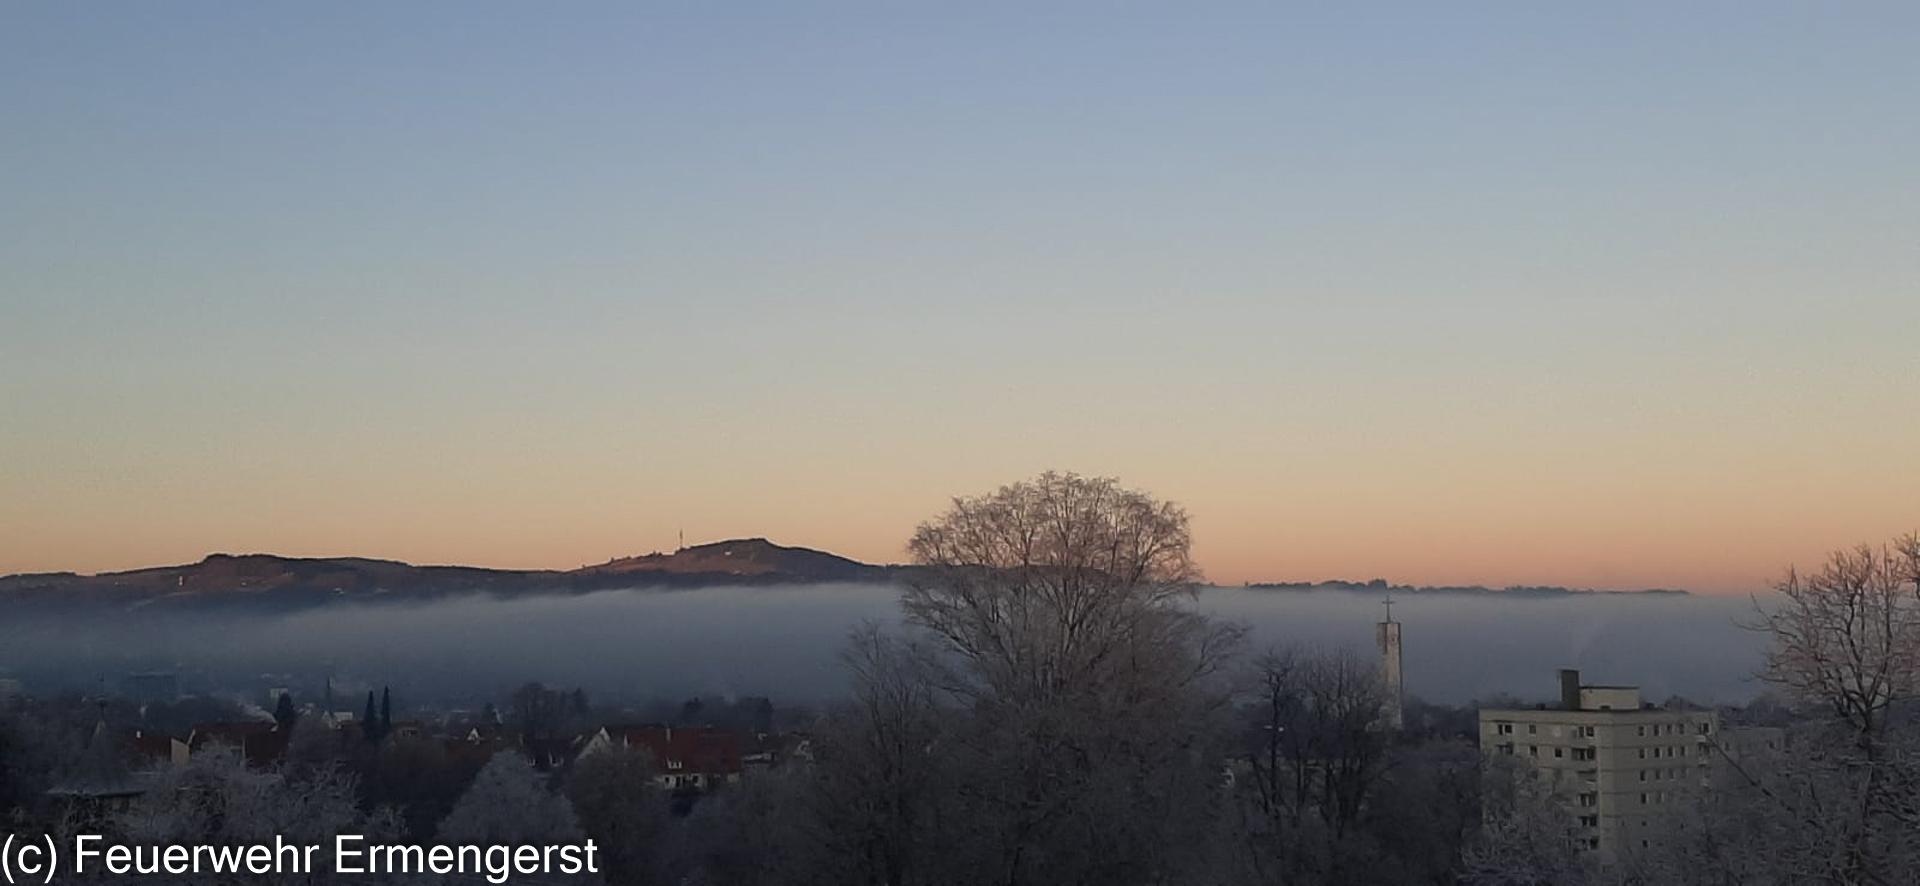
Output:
887,473,1242,886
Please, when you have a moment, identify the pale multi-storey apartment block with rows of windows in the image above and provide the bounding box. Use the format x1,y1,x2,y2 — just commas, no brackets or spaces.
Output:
1480,671,1720,859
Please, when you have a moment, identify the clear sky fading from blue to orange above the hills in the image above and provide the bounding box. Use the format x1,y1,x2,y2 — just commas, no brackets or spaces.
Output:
0,0,1920,592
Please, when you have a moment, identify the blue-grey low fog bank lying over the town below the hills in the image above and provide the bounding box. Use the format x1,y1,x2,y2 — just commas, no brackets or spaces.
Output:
0,584,1764,703
